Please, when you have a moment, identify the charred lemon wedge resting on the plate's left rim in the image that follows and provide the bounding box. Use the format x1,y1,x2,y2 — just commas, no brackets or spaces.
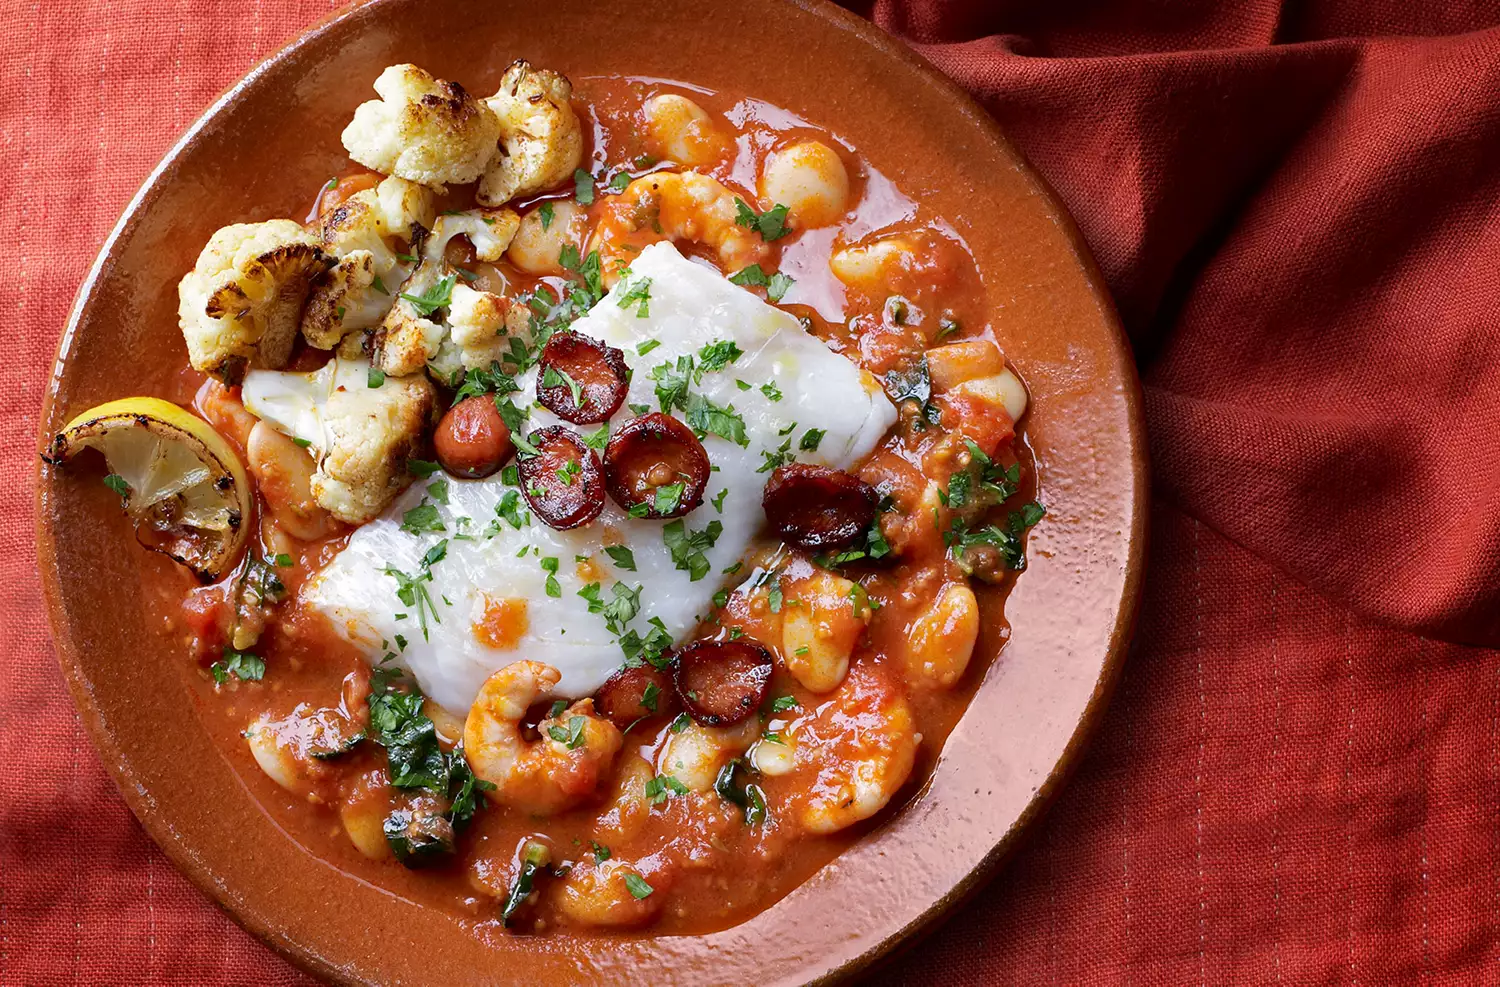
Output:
42,398,251,582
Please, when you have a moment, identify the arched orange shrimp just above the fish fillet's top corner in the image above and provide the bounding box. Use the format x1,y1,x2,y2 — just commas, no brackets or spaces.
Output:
593,171,771,285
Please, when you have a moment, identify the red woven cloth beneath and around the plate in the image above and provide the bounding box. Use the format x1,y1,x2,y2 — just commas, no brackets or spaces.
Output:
0,0,1500,984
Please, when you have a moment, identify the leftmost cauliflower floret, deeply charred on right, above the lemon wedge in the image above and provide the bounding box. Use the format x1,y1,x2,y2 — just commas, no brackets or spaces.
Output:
177,219,333,384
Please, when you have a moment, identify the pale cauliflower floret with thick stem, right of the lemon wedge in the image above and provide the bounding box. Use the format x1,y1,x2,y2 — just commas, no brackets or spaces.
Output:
243,359,437,525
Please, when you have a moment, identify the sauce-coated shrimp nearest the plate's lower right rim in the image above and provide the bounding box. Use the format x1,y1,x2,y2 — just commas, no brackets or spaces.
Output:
783,665,921,833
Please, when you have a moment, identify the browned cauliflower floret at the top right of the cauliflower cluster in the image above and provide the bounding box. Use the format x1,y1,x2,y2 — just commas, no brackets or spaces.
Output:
477,60,584,206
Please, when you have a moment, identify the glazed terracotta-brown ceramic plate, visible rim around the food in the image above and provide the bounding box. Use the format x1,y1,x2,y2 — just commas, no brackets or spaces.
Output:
38,0,1146,984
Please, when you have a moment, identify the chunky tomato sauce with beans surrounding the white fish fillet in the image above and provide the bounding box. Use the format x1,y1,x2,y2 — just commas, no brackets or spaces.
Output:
146,78,1037,938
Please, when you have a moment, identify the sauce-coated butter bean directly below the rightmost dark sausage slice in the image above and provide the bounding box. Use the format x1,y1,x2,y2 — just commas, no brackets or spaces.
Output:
782,569,870,693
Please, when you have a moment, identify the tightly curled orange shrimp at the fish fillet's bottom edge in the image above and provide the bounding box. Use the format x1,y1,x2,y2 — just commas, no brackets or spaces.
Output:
464,662,624,815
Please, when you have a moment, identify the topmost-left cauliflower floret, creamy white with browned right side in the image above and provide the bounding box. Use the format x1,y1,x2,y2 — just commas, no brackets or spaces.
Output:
344,65,500,189
